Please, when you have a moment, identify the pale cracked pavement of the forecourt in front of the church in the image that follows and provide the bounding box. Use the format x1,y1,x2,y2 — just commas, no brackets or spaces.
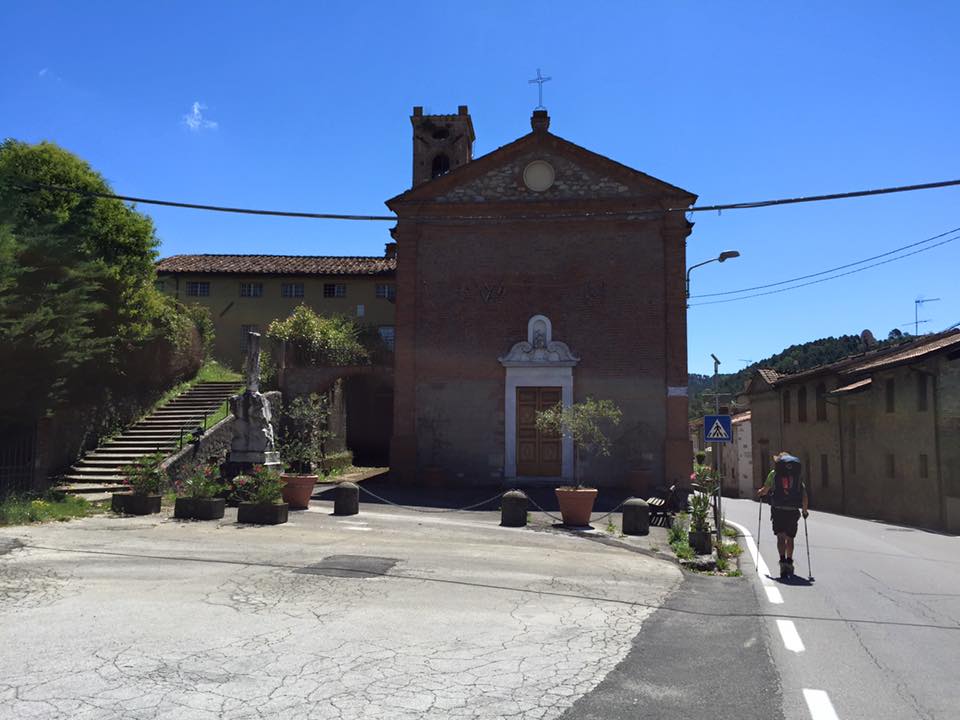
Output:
0,502,681,720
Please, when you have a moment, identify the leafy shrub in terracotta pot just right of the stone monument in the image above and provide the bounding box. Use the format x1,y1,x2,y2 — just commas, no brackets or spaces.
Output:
280,393,333,510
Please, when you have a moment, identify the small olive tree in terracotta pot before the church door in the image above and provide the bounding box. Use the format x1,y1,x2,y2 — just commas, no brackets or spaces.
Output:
537,398,623,527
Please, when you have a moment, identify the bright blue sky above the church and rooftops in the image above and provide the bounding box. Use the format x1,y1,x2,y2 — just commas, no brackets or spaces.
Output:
0,0,960,372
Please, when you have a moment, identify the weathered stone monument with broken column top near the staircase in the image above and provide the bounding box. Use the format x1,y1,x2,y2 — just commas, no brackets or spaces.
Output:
227,332,283,474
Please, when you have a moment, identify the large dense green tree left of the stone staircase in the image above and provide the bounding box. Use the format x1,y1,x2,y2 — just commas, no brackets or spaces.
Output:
0,140,202,422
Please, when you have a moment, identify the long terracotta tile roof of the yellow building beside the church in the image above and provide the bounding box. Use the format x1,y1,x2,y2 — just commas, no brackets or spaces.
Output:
156,255,397,275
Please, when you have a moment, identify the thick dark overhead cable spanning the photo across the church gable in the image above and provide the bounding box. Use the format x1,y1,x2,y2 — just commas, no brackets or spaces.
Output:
11,180,960,222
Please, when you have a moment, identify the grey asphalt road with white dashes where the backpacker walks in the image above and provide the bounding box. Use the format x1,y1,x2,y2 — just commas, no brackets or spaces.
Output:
724,500,960,720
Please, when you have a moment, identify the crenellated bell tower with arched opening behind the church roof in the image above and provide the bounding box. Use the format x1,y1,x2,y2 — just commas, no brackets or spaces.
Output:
410,105,476,187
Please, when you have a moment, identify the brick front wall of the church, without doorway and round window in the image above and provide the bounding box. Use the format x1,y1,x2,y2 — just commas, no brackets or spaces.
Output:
391,128,690,486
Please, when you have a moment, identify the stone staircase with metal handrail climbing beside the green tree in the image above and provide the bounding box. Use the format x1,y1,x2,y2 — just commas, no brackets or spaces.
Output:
60,382,241,500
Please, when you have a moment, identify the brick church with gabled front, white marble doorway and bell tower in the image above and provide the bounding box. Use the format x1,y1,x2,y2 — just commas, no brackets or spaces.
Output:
387,106,696,486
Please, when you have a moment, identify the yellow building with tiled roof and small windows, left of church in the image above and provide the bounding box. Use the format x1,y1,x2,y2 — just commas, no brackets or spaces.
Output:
157,253,396,368
